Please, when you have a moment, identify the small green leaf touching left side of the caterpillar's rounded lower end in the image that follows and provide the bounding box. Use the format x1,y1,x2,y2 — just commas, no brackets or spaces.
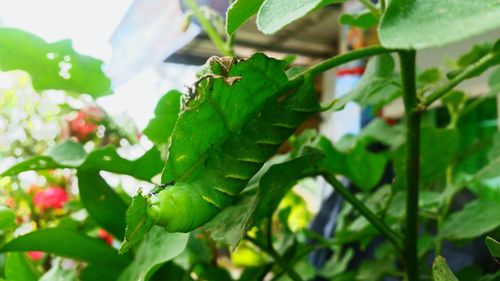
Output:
120,191,153,253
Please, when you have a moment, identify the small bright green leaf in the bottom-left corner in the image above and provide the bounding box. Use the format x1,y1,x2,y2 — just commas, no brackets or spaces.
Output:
5,253,40,281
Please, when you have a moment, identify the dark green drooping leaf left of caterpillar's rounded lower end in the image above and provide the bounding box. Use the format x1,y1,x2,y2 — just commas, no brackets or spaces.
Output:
77,170,127,239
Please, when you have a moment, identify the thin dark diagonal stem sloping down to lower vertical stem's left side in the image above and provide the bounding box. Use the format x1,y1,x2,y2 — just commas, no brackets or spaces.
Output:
322,172,403,253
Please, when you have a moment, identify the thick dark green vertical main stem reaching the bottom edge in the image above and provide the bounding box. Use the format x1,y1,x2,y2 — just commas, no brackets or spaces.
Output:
399,51,421,281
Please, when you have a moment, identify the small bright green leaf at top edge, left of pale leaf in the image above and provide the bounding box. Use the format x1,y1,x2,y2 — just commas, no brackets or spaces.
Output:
226,0,264,35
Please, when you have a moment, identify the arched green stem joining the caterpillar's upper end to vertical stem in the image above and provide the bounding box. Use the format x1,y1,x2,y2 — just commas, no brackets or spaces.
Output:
291,46,393,81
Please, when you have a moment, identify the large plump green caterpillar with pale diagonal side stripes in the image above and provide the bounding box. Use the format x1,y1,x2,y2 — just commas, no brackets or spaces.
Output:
148,54,320,232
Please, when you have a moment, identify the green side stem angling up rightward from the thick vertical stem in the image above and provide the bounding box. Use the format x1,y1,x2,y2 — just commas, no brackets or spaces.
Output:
418,52,500,111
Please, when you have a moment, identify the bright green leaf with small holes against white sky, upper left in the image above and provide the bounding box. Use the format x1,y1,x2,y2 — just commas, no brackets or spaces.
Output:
0,28,111,98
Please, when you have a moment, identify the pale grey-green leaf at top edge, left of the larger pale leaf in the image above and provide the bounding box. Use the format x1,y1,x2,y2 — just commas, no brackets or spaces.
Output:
257,0,345,34
